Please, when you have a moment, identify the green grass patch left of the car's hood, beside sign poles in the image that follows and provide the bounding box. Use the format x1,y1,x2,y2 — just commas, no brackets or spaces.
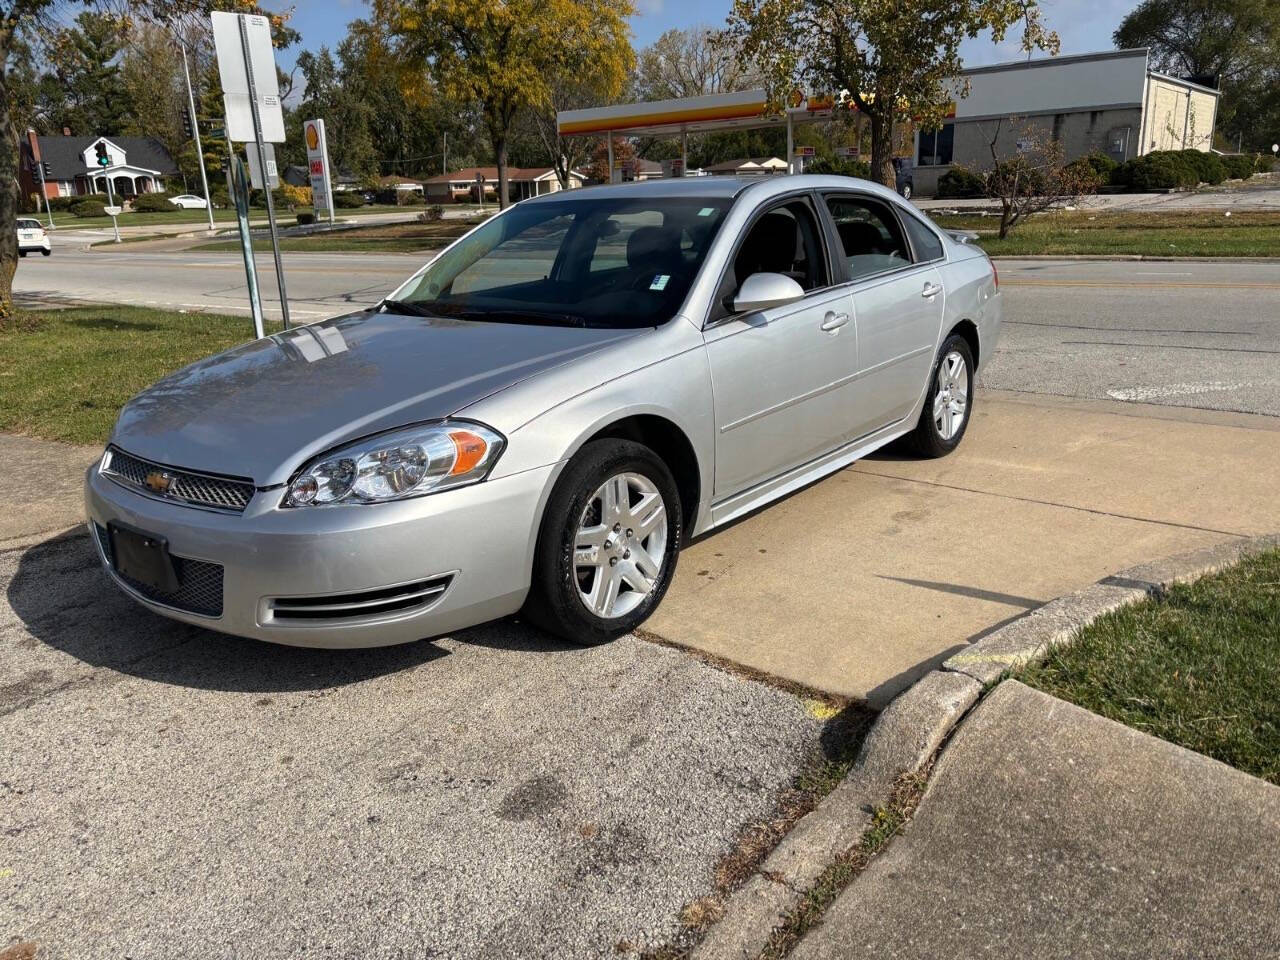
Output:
0,306,275,444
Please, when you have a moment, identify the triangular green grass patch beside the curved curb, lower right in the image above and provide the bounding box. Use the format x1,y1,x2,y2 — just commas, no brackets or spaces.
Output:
1019,550,1280,785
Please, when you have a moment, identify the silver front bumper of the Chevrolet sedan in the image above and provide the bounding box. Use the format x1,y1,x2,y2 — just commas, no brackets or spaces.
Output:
84,455,557,648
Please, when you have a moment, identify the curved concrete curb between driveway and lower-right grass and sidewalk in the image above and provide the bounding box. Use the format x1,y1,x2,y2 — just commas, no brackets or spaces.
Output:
691,534,1280,960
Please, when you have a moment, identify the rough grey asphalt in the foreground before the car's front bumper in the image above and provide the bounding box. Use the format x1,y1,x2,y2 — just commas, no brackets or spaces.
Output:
0,531,831,960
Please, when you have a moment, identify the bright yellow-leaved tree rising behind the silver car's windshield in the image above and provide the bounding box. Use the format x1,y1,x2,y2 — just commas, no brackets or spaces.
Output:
374,0,634,206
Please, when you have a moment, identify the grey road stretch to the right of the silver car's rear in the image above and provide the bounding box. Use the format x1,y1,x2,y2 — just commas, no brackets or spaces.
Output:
983,260,1280,416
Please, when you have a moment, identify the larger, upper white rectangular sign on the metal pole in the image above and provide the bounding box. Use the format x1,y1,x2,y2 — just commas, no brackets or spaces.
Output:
211,10,285,143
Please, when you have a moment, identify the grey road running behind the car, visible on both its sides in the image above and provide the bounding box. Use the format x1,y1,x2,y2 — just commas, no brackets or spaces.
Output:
14,248,1280,416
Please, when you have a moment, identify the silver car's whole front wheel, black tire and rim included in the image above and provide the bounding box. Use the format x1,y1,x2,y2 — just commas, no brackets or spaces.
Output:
522,439,684,645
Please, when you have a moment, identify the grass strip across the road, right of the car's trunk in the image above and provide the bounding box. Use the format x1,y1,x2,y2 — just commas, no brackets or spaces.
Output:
933,210,1280,257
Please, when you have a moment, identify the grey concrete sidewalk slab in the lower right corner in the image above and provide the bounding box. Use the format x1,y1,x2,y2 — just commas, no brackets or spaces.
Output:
791,681,1280,960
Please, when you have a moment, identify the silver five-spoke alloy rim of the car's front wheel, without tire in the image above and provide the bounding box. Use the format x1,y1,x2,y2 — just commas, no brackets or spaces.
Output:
573,472,668,620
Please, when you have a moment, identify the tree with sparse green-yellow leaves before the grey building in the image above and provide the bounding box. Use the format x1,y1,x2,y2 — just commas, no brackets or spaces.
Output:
726,0,1059,187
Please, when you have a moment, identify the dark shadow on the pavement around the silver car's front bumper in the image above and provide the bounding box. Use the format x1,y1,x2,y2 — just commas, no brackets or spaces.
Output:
0,531,465,692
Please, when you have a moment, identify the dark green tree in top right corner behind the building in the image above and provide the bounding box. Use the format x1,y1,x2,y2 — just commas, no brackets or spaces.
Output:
1112,0,1280,150
